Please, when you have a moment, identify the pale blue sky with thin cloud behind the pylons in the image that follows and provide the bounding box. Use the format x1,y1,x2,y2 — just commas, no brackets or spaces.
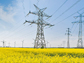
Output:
0,0,84,47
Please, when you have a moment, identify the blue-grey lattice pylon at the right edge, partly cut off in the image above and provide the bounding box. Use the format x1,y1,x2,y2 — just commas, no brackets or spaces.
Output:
72,13,84,47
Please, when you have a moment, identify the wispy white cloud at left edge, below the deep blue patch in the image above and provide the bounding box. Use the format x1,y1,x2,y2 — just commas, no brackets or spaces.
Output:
0,6,16,23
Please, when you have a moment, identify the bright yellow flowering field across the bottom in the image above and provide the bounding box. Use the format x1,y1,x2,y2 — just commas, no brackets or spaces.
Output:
0,48,84,63
